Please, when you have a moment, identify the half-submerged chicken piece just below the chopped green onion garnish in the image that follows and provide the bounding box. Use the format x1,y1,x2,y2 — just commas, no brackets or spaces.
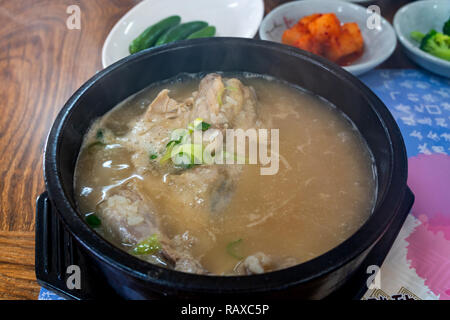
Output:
144,165,242,236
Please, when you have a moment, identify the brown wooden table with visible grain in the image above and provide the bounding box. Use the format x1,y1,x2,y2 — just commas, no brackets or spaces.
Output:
0,0,415,299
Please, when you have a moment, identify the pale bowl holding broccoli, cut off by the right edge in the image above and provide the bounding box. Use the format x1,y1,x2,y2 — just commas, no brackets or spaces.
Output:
394,0,450,78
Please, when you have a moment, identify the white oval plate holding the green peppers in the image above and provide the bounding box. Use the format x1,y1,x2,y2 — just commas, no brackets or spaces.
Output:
102,0,264,68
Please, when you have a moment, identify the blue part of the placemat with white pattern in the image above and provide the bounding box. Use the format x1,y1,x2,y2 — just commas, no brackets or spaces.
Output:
39,70,450,300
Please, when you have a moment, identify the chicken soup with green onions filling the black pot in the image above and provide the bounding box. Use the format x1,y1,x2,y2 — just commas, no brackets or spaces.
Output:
75,73,376,275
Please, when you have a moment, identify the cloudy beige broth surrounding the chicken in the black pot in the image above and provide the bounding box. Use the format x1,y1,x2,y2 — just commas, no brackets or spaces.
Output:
75,75,376,275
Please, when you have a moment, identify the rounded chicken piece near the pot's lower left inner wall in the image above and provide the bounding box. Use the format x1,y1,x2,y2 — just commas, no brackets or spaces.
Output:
98,185,160,244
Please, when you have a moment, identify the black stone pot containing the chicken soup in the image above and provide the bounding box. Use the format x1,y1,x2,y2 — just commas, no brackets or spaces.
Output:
44,38,413,299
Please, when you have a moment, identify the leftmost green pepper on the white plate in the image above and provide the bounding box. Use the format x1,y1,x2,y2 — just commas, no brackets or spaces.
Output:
128,15,181,54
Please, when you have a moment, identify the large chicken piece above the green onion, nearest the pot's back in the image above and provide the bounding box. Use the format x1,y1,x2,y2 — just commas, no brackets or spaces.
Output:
119,74,256,162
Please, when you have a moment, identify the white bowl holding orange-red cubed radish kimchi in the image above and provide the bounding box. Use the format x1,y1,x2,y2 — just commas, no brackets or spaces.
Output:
259,0,397,75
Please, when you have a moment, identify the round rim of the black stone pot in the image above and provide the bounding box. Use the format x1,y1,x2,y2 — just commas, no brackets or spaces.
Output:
44,37,407,293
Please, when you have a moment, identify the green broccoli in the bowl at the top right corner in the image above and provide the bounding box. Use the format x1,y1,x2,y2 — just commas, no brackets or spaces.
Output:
411,18,450,61
